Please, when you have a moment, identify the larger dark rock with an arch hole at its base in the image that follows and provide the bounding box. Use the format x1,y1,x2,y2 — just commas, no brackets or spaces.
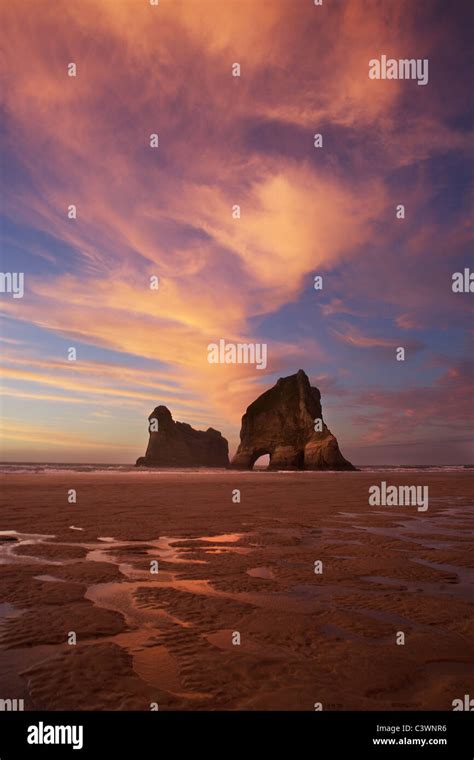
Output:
231,369,356,470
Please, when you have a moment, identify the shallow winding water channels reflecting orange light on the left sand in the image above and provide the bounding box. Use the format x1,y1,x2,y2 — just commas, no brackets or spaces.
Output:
0,531,256,700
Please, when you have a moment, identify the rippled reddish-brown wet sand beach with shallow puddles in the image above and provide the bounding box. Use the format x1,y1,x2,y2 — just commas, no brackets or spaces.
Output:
0,471,474,710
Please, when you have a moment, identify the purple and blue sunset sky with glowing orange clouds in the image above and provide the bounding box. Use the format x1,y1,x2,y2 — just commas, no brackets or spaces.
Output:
0,0,474,465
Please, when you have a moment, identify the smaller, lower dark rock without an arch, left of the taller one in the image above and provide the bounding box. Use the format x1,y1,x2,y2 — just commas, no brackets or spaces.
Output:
137,406,229,467
